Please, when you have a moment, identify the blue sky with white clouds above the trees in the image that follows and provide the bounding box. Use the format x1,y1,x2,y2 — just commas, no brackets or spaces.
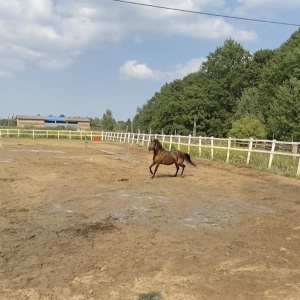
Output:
0,0,300,121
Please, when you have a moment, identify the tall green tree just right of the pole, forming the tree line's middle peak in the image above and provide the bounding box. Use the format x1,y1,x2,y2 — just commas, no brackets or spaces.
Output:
201,39,251,137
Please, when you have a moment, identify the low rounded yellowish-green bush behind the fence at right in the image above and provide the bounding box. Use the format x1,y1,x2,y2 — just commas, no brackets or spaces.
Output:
228,115,267,139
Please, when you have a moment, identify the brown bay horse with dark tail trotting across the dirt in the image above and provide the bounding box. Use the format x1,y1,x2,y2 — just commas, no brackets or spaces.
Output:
148,139,196,178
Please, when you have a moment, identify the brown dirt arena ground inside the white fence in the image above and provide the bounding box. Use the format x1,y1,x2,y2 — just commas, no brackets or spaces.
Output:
0,138,300,300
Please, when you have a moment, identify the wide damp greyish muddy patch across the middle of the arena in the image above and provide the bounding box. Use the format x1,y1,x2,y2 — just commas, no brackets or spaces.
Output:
47,191,275,230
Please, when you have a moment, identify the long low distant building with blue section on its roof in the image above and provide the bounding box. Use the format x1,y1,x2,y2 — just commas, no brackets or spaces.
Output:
15,115,91,130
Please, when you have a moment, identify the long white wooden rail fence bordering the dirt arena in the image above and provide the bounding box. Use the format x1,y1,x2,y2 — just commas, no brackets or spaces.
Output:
0,129,300,176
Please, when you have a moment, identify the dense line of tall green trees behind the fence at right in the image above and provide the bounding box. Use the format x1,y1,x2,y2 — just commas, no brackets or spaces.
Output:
133,29,300,141
